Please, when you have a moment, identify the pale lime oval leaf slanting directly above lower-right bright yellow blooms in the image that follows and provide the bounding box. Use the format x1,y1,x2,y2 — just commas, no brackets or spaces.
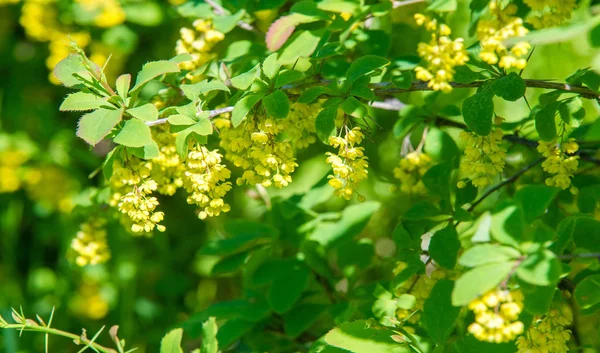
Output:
452,261,515,306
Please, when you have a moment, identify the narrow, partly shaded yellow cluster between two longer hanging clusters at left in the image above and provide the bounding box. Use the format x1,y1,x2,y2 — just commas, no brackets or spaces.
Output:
150,126,185,196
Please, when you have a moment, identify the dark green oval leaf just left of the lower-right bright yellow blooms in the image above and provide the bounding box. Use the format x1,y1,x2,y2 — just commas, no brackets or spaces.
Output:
421,279,460,344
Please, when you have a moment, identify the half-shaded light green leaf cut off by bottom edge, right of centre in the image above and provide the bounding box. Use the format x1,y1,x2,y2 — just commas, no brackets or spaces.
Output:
325,320,410,353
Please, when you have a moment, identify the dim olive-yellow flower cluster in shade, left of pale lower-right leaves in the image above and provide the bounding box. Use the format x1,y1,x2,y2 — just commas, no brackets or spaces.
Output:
396,263,450,324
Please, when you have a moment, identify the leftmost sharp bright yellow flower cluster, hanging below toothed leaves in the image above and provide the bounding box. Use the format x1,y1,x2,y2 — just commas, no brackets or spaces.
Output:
110,160,165,234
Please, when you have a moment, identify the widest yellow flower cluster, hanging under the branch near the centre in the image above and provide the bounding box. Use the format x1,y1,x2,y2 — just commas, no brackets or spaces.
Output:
213,103,319,188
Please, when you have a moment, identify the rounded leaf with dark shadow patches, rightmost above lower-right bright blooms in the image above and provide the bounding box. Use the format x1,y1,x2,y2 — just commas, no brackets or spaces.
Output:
516,250,561,286
